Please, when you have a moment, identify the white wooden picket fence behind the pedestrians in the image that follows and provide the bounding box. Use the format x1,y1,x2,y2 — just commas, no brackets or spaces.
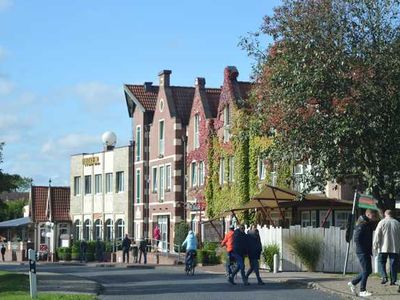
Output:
258,225,375,273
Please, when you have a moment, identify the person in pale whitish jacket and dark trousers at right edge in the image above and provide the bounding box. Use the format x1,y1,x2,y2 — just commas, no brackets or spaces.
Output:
374,210,400,285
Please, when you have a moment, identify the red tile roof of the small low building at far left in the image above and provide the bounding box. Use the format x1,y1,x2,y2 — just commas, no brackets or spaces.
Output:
31,186,71,222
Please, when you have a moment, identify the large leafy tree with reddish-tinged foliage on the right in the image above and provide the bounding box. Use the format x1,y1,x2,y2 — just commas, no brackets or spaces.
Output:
241,0,400,208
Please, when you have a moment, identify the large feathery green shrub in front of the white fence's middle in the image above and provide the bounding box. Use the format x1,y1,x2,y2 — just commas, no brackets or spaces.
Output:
288,234,322,272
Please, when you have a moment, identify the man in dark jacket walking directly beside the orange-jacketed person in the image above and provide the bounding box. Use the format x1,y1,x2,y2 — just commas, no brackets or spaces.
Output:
228,225,249,285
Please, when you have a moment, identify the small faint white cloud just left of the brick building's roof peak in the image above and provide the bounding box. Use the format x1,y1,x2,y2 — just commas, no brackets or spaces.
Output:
74,81,122,110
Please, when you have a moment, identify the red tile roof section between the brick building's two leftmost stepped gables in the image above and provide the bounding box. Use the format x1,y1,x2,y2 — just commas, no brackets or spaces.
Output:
171,86,195,125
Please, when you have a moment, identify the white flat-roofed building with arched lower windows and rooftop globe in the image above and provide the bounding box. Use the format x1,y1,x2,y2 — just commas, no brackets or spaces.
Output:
70,132,133,241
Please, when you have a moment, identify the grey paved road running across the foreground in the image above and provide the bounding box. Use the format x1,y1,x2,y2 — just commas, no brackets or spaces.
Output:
0,265,340,300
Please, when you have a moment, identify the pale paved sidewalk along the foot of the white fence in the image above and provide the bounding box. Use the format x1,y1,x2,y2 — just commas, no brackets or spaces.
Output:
199,265,400,300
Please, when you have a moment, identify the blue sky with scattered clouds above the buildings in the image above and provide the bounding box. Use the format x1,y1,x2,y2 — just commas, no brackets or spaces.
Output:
0,0,280,185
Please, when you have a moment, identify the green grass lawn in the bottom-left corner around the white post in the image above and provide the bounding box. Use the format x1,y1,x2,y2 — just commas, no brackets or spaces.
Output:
0,271,96,300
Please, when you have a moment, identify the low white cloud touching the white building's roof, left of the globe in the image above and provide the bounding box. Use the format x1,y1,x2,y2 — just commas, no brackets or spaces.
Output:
41,133,101,158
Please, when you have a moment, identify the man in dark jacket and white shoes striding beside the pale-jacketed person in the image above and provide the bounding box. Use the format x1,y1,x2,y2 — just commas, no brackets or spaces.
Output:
348,209,376,297
